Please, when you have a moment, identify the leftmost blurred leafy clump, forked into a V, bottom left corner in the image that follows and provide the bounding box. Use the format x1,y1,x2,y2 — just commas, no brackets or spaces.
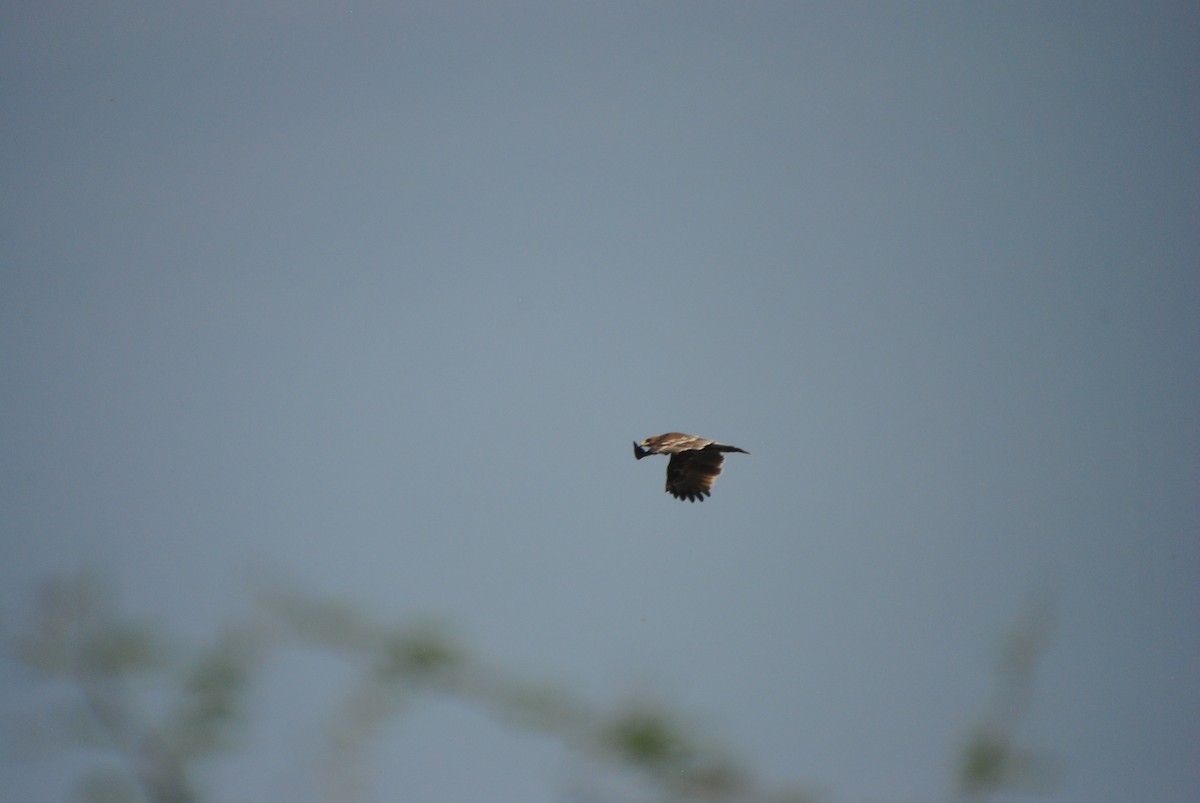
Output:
10,573,254,803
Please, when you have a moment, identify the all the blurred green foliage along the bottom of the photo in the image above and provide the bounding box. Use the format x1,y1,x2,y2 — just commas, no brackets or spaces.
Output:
7,573,1056,803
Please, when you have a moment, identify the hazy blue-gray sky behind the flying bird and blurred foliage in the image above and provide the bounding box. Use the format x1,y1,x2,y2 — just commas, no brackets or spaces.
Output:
0,0,1200,803
